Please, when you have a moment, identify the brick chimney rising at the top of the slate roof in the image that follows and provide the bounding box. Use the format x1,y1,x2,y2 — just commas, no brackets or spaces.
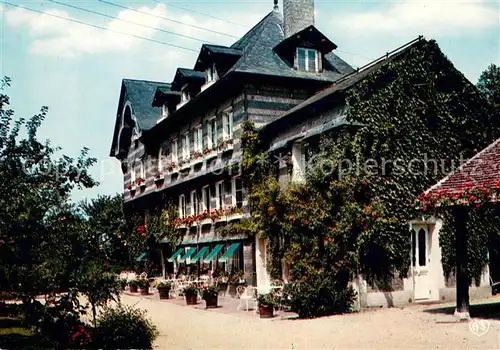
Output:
283,0,314,38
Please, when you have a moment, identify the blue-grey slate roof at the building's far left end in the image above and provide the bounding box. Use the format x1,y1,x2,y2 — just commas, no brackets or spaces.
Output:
123,79,170,130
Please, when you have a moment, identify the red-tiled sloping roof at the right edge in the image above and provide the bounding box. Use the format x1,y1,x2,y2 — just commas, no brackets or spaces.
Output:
425,139,500,195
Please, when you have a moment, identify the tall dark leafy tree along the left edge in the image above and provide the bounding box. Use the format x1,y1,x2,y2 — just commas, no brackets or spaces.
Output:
0,78,97,318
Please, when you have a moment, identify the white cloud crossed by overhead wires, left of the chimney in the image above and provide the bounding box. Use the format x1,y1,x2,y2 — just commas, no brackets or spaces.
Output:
4,4,260,57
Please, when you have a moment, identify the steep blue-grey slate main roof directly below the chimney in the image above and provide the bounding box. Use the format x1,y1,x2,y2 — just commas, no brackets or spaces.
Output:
229,11,354,81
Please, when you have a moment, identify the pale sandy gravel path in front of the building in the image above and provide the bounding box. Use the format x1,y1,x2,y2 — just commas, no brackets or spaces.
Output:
122,295,500,349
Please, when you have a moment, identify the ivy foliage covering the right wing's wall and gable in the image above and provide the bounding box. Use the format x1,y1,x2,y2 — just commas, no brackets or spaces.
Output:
242,40,500,296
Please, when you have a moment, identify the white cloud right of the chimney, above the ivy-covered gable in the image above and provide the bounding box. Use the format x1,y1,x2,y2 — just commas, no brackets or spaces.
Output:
331,0,500,36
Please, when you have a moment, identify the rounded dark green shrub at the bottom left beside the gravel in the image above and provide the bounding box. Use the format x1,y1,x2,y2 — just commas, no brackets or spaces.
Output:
93,305,158,349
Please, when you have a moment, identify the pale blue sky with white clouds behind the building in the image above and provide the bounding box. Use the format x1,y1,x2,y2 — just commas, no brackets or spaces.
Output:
0,0,500,200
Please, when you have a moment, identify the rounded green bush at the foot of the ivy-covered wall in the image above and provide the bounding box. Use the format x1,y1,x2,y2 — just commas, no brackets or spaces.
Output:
285,272,356,318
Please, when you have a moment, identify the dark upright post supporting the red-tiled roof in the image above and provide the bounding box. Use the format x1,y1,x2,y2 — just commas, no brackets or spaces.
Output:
453,206,470,319
